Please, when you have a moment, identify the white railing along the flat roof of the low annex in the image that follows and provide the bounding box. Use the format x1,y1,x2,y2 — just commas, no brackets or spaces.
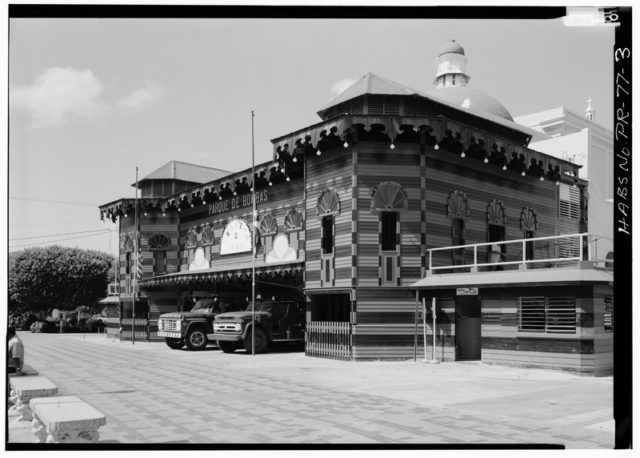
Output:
427,233,613,273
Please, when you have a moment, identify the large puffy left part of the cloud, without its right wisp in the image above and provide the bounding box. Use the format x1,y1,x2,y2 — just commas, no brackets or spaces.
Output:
9,67,105,127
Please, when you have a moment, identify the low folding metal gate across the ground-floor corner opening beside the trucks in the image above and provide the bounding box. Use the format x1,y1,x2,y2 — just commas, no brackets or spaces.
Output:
305,321,351,361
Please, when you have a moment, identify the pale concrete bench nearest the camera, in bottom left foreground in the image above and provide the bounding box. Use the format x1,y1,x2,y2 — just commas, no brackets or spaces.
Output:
29,396,107,443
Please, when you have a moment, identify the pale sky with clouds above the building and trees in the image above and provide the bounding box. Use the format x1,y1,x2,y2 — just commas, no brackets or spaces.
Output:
8,8,614,254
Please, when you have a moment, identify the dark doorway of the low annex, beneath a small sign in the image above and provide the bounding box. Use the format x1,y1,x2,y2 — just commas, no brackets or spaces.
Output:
456,296,482,361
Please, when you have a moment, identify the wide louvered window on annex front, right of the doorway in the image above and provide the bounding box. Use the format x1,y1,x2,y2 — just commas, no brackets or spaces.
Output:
518,296,576,334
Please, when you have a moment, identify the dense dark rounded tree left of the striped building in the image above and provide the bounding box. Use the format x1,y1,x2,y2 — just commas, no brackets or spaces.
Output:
8,245,114,313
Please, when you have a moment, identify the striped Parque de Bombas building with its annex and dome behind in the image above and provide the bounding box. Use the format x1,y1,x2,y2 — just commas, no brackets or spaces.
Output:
100,42,613,374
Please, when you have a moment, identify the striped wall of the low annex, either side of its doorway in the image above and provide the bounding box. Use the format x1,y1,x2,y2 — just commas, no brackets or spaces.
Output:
426,286,613,375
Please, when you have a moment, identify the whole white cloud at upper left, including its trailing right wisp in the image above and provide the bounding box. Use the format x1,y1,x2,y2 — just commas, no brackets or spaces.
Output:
9,67,165,128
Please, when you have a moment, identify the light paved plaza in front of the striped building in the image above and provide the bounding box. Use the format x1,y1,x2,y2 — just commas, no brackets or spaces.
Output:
8,332,614,449
